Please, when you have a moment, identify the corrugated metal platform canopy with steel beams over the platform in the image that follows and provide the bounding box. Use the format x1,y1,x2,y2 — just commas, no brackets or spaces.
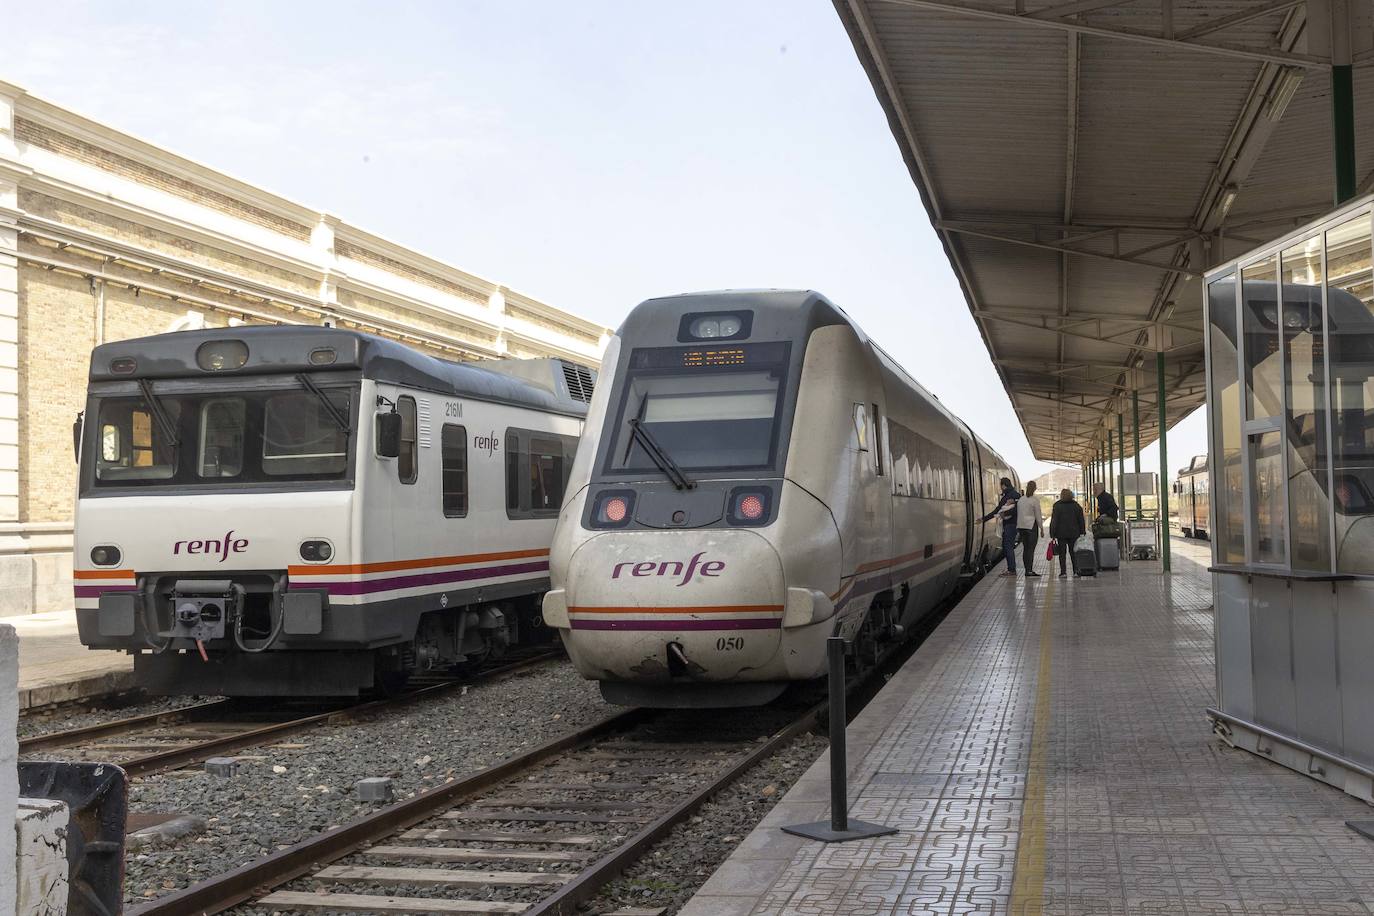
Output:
834,0,1374,463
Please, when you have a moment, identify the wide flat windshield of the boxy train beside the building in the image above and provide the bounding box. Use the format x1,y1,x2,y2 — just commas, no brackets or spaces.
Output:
87,387,356,488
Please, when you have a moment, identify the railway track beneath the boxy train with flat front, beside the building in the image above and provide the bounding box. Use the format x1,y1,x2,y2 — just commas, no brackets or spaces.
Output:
19,651,563,777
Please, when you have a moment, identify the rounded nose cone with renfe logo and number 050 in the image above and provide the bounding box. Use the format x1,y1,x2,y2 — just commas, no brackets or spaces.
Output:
563,530,787,681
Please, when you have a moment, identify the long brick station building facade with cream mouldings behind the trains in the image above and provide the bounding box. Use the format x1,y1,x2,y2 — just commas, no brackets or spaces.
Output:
0,82,611,617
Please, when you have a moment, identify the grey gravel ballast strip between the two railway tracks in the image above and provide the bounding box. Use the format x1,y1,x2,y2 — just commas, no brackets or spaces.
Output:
125,662,607,902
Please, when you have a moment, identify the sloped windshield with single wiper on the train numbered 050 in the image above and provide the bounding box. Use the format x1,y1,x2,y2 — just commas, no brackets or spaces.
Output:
606,345,786,471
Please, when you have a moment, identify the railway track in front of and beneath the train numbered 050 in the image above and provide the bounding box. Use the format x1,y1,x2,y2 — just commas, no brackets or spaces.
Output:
128,640,919,916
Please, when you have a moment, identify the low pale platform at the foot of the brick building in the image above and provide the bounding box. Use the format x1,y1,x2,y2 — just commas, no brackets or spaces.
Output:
0,611,133,710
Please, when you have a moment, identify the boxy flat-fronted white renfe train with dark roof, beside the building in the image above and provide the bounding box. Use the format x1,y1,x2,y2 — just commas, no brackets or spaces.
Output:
74,327,594,696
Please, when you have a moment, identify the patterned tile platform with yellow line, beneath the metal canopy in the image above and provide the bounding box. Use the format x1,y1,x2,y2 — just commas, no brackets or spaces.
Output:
682,541,1374,916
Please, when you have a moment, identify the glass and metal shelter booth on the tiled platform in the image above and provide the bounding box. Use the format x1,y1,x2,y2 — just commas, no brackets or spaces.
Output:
1205,198,1374,801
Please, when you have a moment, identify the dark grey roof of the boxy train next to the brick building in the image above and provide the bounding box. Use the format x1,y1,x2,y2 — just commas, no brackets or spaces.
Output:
89,325,595,416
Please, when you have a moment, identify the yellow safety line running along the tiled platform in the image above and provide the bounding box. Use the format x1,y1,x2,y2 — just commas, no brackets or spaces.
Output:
1010,580,1054,916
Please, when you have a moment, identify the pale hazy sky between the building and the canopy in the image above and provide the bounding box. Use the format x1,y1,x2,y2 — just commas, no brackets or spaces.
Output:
10,0,1206,478
